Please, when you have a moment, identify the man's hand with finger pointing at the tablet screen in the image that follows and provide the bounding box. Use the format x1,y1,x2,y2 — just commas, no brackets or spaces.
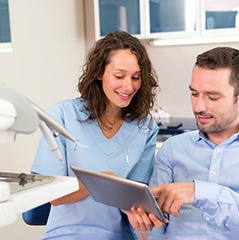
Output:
150,182,195,217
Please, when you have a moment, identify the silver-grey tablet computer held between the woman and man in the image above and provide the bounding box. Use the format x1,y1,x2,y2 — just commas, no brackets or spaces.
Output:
71,166,164,222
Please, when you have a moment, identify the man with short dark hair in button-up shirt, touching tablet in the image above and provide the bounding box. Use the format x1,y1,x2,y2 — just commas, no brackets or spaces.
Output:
128,47,239,240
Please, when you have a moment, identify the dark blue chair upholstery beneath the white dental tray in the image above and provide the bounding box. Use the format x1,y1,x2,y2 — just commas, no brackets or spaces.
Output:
22,203,51,226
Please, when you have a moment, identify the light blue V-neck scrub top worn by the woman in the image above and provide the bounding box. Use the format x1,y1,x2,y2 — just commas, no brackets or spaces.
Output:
31,98,158,240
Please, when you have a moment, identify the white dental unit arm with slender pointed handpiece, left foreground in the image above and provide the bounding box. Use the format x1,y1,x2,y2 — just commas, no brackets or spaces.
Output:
0,83,86,147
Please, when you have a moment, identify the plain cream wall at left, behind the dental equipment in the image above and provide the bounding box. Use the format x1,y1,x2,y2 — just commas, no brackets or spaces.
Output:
0,0,85,240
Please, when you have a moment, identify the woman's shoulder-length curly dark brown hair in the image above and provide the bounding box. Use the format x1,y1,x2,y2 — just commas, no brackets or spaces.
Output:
77,31,158,123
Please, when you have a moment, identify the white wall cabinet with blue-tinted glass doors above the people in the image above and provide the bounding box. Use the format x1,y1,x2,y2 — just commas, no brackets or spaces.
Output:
85,0,239,47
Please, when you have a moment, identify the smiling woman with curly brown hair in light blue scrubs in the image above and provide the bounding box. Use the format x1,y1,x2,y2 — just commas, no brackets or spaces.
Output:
32,32,158,240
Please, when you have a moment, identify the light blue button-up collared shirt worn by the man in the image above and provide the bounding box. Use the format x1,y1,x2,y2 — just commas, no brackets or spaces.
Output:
148,130,239,240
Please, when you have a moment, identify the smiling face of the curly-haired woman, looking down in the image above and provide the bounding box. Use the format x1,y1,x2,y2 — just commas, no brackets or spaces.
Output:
99,49,142,111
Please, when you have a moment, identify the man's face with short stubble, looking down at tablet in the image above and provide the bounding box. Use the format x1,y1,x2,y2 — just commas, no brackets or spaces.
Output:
189,67,239,134
